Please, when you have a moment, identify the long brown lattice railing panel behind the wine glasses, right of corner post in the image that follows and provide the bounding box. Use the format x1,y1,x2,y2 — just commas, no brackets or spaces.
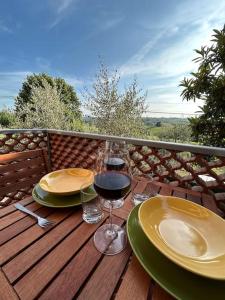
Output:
49,133,225,200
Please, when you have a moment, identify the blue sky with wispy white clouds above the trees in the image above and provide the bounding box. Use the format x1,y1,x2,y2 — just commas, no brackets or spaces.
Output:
0,0,225,116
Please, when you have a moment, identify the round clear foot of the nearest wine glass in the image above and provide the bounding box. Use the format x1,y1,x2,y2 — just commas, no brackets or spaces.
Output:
94,224,127,255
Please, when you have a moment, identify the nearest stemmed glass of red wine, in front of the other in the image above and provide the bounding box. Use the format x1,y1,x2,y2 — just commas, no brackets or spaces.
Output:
94,155,131,255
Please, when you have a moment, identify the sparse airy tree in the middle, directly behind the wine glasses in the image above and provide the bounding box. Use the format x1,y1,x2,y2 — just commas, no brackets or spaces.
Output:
83,64,146,136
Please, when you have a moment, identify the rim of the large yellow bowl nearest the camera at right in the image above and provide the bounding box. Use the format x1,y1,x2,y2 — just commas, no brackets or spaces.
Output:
138,195,225,281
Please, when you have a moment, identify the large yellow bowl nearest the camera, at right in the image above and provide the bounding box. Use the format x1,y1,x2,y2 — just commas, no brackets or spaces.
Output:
138,196,225,280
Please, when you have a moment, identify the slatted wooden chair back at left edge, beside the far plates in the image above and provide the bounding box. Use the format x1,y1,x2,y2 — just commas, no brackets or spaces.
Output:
0,150,49,207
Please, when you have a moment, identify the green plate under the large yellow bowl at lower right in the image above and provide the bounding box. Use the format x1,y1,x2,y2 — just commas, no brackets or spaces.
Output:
127,206,225,300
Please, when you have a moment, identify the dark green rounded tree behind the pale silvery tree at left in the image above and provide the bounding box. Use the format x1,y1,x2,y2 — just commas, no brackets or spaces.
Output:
15,73,81,120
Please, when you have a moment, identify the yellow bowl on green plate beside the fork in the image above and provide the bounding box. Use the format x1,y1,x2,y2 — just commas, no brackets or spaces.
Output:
39,168,94,195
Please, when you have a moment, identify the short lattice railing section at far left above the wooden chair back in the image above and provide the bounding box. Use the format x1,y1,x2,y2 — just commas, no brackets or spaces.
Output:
0,131,47,154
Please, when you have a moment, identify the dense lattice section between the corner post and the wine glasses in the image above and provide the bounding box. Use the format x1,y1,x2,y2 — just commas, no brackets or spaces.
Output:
49,133,104,170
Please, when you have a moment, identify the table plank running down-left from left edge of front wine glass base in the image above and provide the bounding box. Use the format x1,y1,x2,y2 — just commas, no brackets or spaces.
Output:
39,234,102,300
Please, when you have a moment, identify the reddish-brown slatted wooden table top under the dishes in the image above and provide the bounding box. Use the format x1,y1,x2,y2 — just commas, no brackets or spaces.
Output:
0,180,219,300
